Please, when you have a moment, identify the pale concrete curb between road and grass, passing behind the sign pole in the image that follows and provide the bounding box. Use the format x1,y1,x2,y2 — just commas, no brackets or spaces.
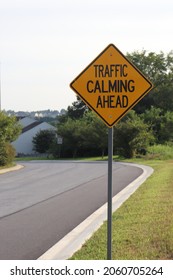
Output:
38,163,153,260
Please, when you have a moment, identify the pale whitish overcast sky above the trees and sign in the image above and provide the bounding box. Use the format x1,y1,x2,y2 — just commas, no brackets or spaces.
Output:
0,0,173,111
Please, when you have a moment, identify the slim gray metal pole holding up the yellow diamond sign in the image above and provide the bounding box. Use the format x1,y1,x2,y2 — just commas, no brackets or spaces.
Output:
107,127,113,260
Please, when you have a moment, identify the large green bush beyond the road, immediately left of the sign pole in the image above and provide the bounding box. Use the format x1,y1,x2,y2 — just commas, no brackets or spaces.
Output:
58,111,107,160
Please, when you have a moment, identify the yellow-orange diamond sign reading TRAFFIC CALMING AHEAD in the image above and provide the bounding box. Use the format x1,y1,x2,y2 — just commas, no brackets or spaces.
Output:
70,44,153,127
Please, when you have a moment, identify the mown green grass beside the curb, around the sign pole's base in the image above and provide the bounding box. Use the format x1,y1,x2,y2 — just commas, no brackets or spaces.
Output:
71,160,173,260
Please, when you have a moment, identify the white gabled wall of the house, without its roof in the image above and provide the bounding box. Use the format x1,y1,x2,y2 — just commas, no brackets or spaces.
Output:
12,122,56,155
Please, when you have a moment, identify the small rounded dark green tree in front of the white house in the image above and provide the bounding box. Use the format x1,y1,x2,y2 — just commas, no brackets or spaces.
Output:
32,129,56,154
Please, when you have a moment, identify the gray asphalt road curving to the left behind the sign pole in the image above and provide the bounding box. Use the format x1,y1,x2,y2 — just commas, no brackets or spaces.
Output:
0,161,142,260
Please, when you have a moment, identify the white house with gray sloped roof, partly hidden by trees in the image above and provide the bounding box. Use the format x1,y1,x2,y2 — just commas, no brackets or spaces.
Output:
11,117,56,155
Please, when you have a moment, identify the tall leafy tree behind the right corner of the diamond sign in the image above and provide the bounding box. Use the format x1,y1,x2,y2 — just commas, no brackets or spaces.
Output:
127,50,173,113
